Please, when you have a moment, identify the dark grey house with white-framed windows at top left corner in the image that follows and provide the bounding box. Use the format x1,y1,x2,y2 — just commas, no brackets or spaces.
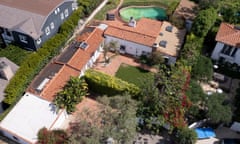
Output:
0,0,76,50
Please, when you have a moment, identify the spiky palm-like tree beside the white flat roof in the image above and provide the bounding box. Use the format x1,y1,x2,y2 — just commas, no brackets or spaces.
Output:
54,77,88,113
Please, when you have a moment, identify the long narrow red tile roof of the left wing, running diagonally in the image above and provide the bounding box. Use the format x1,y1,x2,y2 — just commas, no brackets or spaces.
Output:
40,28,103,101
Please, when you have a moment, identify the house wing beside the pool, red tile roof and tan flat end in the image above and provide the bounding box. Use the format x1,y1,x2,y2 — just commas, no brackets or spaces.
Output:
104,18,185,64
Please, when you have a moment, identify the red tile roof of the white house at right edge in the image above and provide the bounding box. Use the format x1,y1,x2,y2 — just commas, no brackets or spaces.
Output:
216,23,240,47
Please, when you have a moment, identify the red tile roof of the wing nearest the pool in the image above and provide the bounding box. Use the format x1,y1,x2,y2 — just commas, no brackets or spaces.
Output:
104,18,162,46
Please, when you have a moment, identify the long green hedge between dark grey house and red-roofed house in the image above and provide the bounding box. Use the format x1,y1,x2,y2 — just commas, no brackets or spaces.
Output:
4,7,83,105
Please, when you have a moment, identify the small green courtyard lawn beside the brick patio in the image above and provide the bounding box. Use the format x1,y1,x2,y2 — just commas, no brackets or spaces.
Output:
115,64,153,87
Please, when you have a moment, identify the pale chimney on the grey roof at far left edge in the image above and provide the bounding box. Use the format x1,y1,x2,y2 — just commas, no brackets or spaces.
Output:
0,61,13,80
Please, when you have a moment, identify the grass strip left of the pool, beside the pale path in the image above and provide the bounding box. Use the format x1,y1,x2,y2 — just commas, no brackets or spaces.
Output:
94,0,120,20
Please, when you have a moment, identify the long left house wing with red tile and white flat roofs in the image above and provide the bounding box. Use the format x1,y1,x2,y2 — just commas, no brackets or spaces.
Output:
0,27,104,144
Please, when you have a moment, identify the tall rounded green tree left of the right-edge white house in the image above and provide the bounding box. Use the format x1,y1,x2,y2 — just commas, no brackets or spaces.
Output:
192,8,217,37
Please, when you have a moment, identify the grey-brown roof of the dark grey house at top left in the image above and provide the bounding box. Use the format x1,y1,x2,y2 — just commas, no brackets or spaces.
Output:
0,0,71,39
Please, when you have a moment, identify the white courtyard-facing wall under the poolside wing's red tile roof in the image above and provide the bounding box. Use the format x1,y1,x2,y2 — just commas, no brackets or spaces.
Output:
105,35,152,56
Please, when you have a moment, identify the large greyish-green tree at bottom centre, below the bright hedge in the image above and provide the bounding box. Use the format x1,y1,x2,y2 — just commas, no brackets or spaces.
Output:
69,94,137,144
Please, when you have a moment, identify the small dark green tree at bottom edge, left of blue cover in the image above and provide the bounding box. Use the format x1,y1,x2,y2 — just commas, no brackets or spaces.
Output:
175,127,197,144
